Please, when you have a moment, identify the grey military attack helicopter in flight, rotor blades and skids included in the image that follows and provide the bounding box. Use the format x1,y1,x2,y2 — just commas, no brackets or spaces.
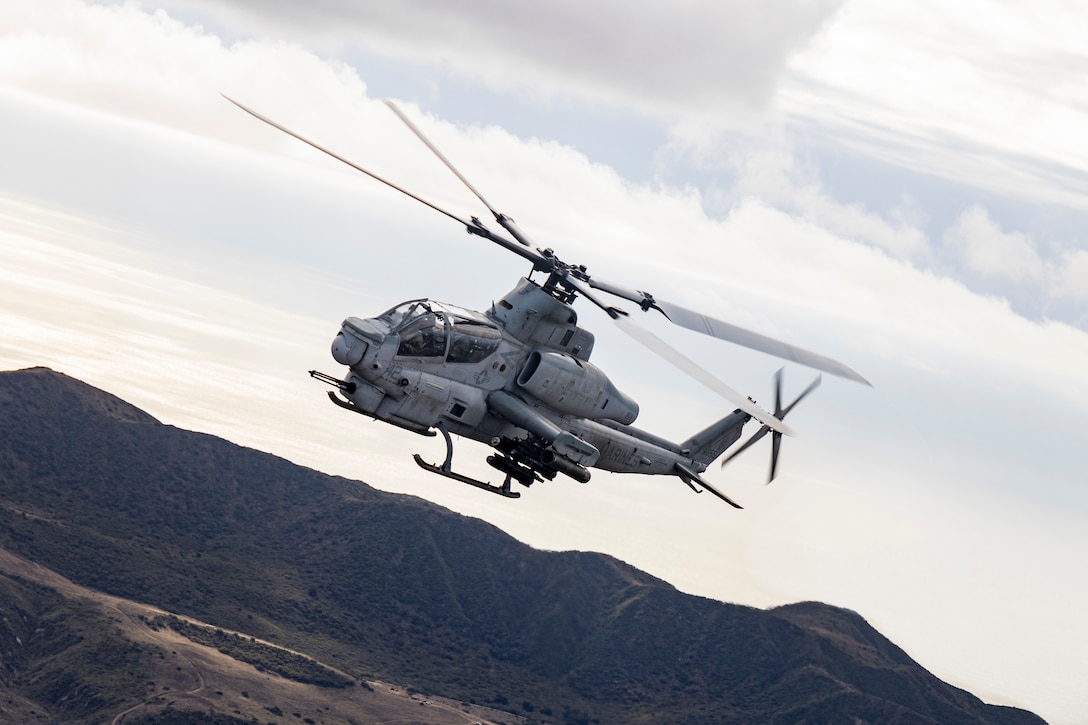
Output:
224,96,870,508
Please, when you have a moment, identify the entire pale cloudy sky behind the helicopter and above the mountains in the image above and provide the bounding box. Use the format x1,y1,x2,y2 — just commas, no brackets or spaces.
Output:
0,0,1088,725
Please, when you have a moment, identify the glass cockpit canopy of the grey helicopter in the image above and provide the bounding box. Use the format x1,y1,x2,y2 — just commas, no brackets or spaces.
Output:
378,299,503,363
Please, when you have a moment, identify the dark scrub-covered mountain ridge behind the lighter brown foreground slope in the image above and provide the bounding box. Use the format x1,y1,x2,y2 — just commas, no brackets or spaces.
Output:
0,369,1041,723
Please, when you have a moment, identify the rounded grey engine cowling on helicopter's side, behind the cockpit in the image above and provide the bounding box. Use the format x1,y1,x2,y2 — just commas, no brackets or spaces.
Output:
518,351,639,425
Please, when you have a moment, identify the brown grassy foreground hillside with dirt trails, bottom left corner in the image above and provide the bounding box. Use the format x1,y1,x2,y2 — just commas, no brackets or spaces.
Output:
0,551,526,725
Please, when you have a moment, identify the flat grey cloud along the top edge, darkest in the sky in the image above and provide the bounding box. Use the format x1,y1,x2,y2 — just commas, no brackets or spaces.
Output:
136,0,843,116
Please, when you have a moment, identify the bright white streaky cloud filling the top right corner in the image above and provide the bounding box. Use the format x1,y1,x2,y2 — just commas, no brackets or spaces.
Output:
781,0,1088,211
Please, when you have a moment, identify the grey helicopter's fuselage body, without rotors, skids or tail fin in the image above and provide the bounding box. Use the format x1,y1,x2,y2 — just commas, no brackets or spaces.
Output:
332,279,726,478
